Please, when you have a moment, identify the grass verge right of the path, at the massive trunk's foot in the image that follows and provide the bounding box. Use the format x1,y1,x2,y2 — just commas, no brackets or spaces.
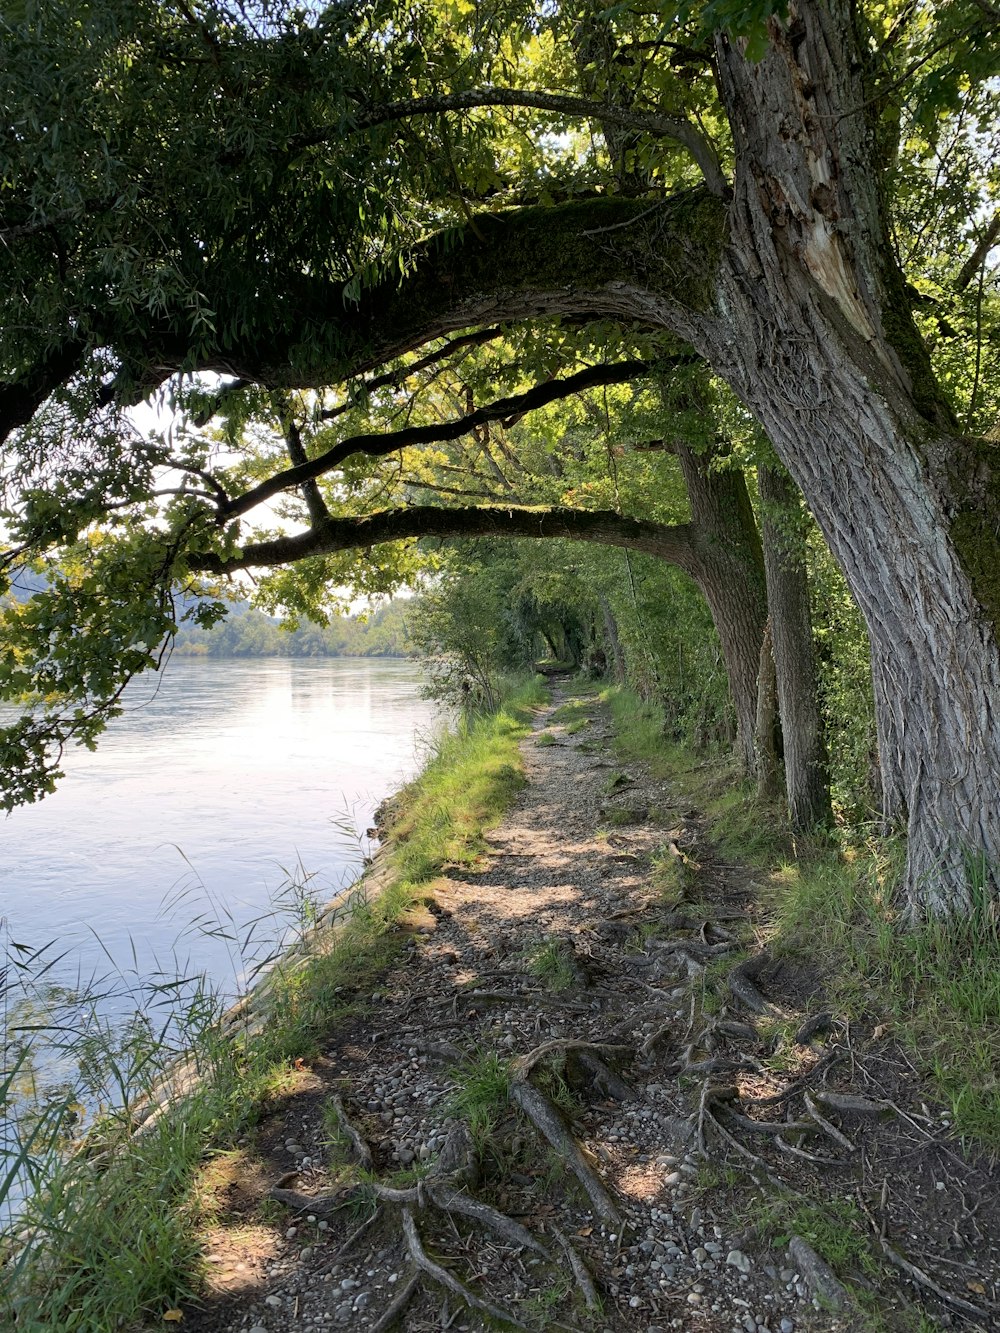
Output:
605,690,1000,1152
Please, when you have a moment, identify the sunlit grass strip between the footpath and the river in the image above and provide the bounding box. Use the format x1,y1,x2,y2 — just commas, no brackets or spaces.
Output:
0,682,544,1333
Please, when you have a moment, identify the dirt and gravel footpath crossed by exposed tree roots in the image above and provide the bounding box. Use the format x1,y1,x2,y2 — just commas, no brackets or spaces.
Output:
184,701,1000,1333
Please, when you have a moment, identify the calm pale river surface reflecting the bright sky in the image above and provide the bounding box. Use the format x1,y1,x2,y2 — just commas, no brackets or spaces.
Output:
0,659,437,989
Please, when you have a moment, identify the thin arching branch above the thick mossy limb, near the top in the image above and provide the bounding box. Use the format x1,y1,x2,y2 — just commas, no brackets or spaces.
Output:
293,88,729,199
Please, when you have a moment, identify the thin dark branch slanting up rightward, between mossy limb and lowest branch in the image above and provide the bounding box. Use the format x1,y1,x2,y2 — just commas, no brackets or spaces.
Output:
219,353,697,523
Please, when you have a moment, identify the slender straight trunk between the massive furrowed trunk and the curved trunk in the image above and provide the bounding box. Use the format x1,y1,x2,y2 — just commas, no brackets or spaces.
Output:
757,467,832,830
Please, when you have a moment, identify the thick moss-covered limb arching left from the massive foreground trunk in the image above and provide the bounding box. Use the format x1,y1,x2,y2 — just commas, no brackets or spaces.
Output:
137,188,728,389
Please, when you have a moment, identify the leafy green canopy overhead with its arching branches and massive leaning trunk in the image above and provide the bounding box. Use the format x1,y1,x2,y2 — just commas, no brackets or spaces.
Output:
0,0,1000,909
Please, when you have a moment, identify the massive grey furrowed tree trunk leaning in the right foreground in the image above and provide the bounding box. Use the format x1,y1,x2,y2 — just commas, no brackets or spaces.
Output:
703,0,1000,913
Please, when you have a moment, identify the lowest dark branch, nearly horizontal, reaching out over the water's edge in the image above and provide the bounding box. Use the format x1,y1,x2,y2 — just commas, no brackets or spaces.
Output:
191,505,700,579
